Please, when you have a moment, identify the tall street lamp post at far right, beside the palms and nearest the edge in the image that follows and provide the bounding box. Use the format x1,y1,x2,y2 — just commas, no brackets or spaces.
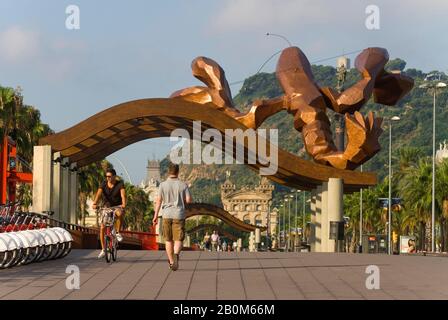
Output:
420,74,447,252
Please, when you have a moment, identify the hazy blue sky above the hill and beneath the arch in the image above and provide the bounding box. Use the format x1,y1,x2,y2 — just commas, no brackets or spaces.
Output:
0,0,448,183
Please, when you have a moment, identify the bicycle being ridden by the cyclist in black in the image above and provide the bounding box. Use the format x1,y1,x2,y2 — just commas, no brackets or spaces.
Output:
99,206,121,263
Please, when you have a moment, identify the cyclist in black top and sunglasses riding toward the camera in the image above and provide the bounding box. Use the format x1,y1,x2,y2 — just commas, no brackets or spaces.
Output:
92,169,126,259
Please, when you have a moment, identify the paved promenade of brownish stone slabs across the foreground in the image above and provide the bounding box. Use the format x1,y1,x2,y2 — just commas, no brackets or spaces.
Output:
0,250,448,300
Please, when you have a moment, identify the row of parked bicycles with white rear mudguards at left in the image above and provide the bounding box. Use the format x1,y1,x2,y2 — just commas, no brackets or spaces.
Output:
0,203,73,268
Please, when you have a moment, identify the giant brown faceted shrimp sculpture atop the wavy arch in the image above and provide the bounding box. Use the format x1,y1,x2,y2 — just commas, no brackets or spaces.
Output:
171,47,414,170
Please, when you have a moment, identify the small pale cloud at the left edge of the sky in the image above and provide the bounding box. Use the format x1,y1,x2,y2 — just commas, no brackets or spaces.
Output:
0,26,40,62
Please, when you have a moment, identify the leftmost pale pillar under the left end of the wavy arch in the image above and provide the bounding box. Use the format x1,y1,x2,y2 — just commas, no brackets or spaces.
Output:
33,146,52,212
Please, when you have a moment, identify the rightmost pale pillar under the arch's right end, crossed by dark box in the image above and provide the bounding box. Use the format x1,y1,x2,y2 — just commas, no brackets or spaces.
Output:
328,178,344,252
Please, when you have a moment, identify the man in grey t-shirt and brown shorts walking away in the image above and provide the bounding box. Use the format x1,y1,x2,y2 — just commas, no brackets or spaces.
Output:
152,163,193,271
